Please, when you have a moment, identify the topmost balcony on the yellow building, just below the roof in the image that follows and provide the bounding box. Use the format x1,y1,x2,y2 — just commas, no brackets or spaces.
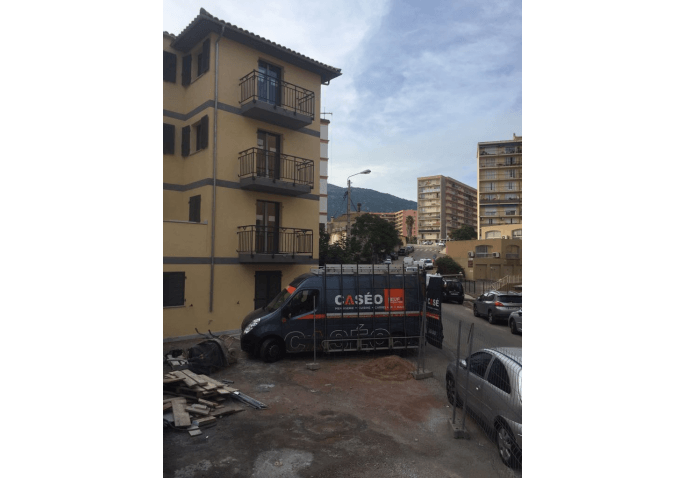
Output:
240,70,315,129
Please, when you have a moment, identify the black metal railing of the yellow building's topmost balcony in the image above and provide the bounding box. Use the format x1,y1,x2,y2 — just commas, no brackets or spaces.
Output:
240,70,314,120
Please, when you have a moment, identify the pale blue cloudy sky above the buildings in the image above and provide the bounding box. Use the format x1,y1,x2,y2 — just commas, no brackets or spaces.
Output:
163,0,522,201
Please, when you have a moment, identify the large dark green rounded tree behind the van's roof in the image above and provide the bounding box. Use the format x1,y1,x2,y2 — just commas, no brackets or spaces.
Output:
349,214,402,262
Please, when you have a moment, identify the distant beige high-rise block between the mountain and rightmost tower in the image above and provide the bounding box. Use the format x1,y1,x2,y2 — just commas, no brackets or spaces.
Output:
416,175,477,241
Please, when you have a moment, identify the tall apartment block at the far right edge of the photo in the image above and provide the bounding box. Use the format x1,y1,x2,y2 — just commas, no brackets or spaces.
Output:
476,135,522,239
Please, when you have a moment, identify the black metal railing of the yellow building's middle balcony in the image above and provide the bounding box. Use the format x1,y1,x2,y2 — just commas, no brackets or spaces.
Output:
238,148,314,187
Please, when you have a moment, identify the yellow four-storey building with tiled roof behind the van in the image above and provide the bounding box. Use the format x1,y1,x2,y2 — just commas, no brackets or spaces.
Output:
163,9,341,340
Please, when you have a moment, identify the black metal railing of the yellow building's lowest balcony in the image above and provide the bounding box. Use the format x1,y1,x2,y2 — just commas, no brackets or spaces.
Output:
237,225,314,256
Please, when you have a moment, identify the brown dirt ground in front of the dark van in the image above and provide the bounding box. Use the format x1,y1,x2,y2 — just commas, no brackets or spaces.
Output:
163,342,521,478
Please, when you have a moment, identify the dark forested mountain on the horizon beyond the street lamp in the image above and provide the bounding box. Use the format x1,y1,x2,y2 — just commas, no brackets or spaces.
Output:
327,184,417,220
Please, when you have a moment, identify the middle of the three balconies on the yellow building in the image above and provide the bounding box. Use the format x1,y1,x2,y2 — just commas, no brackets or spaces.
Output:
238,148,314,196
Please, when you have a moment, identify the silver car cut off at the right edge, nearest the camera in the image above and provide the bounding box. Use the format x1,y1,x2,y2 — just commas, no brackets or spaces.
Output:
445,347,522,468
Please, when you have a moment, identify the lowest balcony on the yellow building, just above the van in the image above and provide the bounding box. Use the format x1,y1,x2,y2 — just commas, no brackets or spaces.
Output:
236,225,314,264
